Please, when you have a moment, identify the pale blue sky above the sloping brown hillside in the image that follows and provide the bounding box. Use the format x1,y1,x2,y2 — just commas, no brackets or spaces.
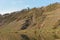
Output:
0,0,60,14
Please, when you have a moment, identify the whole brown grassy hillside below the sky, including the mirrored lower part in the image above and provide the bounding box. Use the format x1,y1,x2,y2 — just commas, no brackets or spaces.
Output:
0,3,60,40
